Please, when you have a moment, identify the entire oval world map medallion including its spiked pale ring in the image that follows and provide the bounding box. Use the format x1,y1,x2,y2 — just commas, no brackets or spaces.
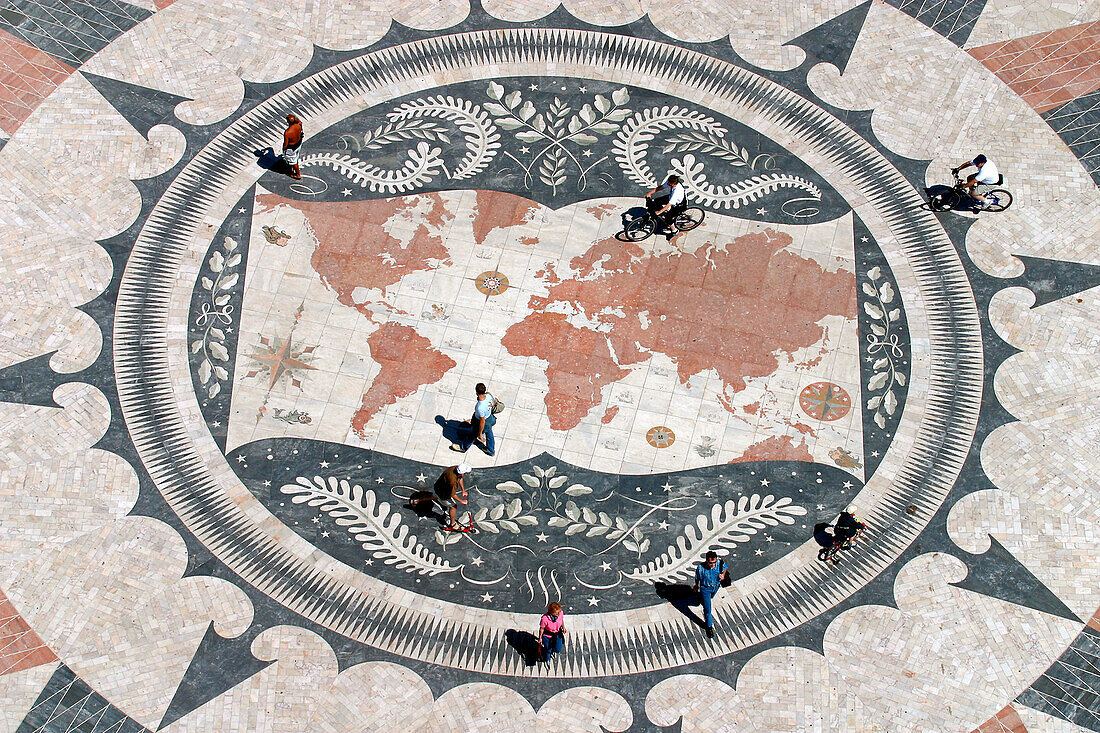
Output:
117,29,981,677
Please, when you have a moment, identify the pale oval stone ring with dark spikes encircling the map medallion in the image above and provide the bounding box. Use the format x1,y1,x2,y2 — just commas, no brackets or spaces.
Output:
114,29,982,677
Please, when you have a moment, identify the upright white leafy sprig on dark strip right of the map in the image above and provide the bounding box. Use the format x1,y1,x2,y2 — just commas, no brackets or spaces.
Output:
862,267,905,429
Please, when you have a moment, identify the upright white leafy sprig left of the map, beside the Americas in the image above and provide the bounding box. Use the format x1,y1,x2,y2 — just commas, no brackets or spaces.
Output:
191,237,243,400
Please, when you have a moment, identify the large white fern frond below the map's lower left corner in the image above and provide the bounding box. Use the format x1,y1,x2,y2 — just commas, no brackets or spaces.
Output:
282,475,461,576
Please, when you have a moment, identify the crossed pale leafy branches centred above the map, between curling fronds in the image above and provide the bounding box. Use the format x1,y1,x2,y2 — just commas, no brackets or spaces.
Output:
485,81,630,195
